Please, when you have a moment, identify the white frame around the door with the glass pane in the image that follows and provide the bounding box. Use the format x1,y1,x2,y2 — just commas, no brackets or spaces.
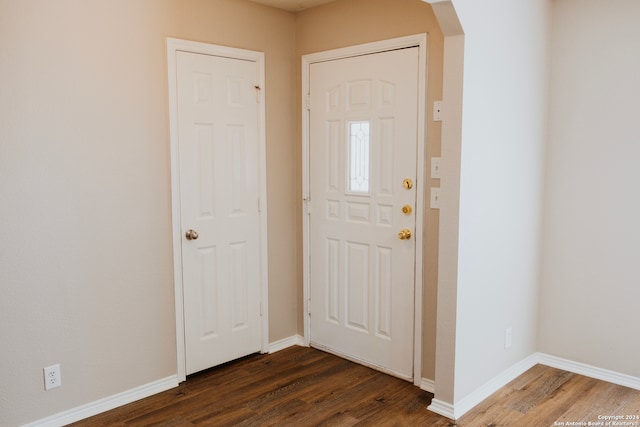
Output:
301,34,427,386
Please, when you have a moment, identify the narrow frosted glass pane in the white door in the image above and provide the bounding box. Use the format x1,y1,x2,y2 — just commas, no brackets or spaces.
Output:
348,122,370,194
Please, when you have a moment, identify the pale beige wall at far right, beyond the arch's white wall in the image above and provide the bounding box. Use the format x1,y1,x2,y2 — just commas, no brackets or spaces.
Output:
539,0,640,378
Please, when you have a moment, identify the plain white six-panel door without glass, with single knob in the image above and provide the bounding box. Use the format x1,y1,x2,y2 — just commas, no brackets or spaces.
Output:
176,51,264,374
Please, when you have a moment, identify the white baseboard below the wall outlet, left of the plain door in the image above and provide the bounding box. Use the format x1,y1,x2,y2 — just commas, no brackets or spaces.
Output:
24,375,178,427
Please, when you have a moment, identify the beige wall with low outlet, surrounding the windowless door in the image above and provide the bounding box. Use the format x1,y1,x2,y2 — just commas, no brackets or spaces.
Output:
0,0,300,426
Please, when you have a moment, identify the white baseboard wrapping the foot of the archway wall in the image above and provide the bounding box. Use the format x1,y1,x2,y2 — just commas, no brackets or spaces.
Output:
427,354,538,420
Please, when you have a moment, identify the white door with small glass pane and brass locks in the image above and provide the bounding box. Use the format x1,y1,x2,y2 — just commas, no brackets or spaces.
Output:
309,47,419,379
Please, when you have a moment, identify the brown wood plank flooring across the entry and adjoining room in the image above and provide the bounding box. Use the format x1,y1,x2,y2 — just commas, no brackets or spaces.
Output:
73,347,640,427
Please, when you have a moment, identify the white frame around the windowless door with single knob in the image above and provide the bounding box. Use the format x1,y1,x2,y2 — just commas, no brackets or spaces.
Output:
167,38,269,381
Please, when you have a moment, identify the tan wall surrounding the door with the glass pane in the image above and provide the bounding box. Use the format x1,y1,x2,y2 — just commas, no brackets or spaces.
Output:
296,0,443,379
